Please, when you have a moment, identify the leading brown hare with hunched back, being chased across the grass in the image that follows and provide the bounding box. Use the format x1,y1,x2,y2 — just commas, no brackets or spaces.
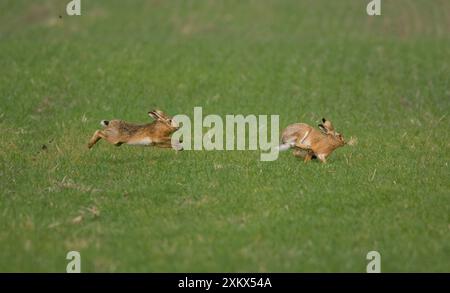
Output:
279,118,346,163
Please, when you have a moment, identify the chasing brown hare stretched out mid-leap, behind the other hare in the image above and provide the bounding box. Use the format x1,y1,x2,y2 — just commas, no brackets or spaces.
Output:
88,110,182,150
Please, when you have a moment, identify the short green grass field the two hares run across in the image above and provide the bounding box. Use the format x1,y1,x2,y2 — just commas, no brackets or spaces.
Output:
0,0,450,272
